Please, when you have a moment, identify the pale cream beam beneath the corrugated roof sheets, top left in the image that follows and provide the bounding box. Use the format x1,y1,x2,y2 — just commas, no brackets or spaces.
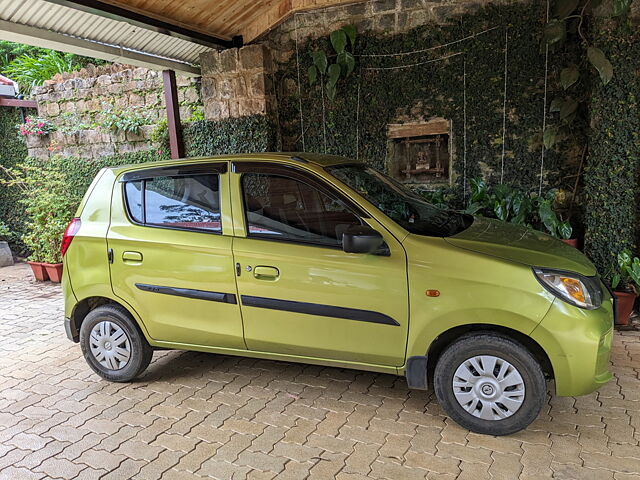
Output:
0,20,200,76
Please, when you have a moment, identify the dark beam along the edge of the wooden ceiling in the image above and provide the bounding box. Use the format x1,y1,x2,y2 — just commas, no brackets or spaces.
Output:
46,0,242,48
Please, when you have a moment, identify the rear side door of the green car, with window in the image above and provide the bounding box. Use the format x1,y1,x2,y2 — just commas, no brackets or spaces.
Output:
107,162,245,349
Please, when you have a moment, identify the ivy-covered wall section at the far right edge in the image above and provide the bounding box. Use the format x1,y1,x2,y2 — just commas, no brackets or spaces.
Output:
584,16,640,274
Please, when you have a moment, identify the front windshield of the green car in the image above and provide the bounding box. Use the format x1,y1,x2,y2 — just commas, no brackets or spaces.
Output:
326,165,473,237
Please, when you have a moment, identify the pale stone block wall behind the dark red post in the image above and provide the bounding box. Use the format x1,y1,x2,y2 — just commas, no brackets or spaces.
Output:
27,65,202,159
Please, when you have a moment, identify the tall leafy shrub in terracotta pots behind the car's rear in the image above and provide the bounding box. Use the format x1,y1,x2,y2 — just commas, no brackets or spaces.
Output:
2,163,77,282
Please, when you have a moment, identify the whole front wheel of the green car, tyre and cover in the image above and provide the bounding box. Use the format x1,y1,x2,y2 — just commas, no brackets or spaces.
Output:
433,333,546,435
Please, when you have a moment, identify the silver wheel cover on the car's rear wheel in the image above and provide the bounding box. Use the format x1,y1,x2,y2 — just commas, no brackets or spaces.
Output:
89,321,131,370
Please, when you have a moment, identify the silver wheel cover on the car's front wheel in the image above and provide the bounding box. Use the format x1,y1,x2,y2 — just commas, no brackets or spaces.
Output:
453,355,525,420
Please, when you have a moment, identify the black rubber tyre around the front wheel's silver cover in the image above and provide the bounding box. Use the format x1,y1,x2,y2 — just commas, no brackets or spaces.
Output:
433,332,547,435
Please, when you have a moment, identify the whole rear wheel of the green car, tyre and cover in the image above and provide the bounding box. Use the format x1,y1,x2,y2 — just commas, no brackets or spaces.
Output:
80,305,153,382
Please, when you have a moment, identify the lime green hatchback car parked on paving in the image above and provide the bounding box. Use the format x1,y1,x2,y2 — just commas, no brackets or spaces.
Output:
62,153,614,435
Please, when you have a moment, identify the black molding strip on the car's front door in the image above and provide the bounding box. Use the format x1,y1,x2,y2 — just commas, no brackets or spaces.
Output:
240,295,400,326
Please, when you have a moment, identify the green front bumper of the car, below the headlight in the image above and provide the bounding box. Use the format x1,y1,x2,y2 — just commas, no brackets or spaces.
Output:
531,295,614,396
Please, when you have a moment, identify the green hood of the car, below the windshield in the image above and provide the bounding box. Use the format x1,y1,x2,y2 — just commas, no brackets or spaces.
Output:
445,217,597,277
